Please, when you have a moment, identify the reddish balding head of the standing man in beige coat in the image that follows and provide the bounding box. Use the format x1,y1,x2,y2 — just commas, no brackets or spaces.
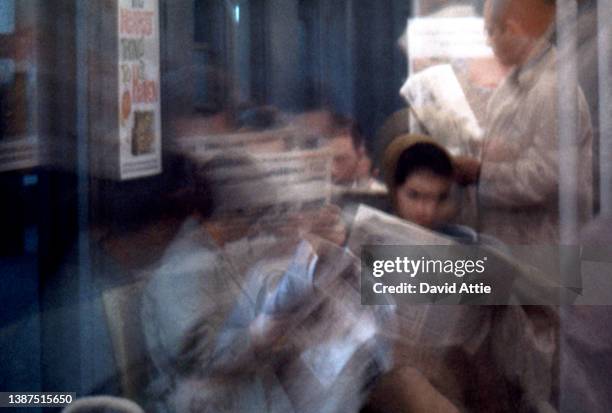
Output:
484,0,555,66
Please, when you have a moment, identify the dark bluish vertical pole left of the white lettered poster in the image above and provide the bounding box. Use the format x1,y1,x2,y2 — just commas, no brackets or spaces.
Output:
75,0,96,394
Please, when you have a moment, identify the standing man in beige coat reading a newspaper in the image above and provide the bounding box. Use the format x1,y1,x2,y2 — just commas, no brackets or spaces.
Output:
444,0,568,411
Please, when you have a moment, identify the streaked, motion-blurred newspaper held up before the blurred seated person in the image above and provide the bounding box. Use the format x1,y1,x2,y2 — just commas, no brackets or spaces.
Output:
177,127,331,215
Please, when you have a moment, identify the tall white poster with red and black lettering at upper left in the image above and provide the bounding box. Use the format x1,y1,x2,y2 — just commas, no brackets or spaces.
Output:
117,0,161,180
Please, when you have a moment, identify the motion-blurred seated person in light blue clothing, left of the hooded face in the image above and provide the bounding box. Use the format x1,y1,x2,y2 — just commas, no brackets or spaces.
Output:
142,151,389,412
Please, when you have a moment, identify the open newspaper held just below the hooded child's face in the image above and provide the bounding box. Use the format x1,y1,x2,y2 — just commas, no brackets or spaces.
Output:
348,206,579,365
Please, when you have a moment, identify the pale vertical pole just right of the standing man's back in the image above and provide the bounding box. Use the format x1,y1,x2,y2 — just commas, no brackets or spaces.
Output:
557,0,590,245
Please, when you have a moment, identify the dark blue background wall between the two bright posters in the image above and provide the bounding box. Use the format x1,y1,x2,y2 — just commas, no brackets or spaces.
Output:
170,0,410,140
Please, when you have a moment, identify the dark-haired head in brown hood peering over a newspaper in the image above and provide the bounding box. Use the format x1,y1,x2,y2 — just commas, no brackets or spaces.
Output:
384,135,455,229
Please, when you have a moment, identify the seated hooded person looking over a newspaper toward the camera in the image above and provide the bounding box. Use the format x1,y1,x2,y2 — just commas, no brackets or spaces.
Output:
374,135,558,412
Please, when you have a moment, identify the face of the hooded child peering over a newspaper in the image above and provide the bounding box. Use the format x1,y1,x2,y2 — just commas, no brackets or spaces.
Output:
396,170,455,229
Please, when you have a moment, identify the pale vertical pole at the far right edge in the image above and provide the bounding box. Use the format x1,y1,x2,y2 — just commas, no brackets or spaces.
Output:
597,0,612,215
